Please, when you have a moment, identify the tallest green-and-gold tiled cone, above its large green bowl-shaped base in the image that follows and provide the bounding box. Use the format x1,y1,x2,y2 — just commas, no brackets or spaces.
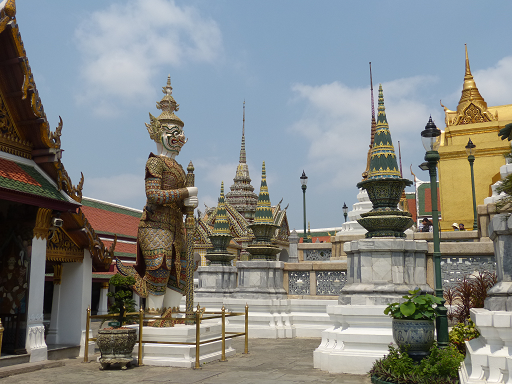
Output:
368,85,401,180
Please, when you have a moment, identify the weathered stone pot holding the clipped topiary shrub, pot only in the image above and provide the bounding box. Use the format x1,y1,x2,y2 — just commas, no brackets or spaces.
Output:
96,328,137,369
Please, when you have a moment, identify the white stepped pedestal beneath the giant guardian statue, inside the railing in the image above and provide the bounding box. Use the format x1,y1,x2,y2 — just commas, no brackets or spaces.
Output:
133,319,236,368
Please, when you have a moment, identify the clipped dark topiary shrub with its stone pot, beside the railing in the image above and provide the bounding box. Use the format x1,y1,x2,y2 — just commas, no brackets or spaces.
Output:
96,274,137,370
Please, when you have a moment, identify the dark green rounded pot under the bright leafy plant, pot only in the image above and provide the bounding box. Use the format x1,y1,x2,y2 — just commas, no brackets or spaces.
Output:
392,319,435,361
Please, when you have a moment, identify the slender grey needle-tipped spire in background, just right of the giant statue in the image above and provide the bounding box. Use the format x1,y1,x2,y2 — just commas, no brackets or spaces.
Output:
226,100,258,222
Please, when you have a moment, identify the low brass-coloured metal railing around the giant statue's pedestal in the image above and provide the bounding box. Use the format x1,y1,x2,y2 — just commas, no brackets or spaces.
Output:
84,304,249,369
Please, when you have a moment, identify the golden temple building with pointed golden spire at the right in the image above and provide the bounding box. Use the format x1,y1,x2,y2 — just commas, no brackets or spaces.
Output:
439,47,512,230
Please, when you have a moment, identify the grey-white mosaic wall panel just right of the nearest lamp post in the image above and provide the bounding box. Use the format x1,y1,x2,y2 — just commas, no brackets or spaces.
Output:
441,256,496,288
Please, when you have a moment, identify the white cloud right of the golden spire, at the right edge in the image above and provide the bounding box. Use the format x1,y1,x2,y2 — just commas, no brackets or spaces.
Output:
473,56,512,106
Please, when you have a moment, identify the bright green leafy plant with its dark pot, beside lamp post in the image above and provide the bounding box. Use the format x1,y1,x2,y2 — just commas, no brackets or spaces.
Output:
384,288,441,361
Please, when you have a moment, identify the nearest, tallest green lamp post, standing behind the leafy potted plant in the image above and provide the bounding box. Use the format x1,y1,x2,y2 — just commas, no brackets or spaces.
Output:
421,116,449,348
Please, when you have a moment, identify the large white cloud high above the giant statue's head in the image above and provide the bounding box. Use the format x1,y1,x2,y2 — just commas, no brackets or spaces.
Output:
75,0,223,115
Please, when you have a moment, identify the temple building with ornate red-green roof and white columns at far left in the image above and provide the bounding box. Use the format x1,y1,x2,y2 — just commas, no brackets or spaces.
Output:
0,0,116,361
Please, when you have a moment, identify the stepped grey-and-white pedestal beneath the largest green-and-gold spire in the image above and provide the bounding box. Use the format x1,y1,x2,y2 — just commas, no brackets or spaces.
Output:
313,238,433,374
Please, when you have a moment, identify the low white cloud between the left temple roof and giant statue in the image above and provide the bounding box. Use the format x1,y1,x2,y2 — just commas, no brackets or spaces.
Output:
84,174,146,209
